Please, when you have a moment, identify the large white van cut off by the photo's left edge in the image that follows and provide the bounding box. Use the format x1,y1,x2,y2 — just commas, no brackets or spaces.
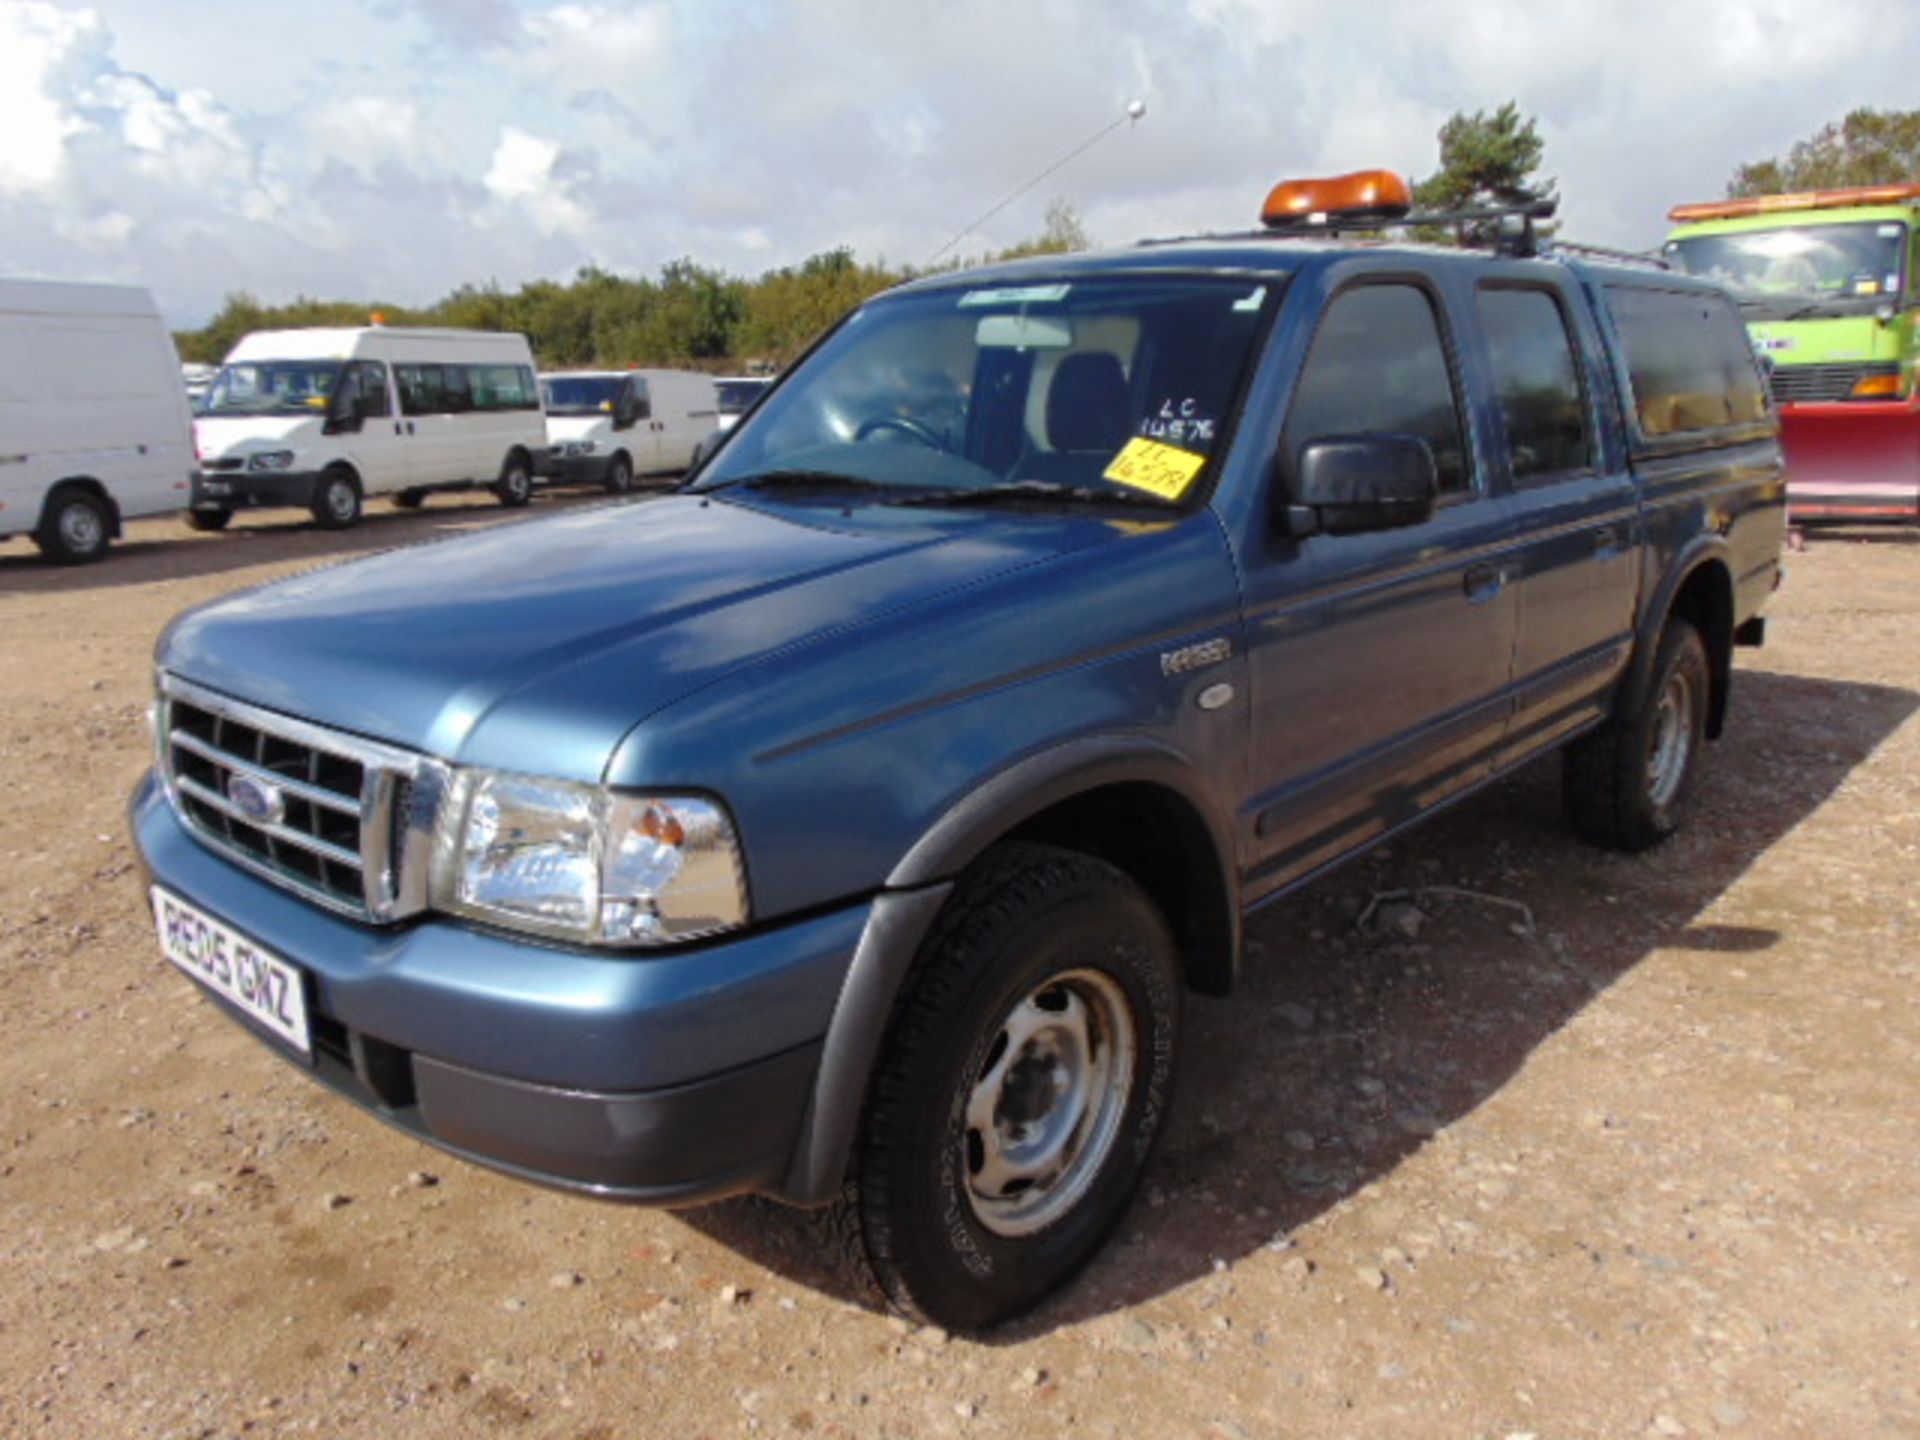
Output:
0,280,194,564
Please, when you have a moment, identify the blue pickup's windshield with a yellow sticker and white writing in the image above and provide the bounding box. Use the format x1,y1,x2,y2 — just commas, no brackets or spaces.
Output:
697,273,1284,503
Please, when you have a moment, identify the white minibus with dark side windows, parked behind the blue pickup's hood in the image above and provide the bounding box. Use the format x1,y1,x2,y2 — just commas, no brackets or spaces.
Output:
188,324,547,530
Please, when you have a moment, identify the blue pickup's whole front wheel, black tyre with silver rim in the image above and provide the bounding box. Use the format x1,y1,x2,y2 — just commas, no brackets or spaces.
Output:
841,843,1181,1331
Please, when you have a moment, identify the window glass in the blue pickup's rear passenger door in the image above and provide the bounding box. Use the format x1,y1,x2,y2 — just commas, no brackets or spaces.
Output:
1475,286,1594,482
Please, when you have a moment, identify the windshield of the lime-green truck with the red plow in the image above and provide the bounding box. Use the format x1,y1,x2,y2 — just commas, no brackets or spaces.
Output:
1667,221,1907,301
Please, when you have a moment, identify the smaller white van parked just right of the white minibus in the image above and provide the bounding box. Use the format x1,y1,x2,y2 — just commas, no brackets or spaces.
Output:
540,371,718,495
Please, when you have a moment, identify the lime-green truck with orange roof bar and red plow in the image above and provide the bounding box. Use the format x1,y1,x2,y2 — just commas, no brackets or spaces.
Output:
1665,184,1920,520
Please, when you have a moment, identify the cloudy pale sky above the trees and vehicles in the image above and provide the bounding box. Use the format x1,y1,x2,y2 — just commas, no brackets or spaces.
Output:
0,0,1920,324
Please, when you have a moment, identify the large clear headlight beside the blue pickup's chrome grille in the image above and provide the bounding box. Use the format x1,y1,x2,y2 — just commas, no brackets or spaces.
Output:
434,770,747,945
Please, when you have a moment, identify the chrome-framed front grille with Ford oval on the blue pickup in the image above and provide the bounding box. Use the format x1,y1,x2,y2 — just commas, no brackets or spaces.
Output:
157,676,444,920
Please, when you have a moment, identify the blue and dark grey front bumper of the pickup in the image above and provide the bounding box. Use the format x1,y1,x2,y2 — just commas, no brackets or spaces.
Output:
129,774,872,1204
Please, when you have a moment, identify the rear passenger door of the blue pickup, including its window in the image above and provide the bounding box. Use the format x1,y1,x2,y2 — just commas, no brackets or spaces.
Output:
1473,265,1642,764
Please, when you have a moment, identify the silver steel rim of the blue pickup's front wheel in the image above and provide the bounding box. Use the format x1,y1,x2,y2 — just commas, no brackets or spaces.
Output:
960,970,1139,1236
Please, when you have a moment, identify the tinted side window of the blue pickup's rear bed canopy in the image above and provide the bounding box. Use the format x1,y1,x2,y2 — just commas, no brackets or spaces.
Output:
1607,286,1766,440
